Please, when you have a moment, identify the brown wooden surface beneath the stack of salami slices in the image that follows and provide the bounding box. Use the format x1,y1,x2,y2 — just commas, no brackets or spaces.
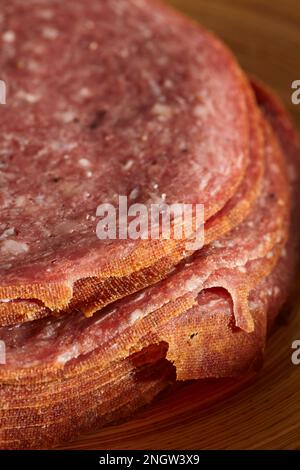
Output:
62,0,300,450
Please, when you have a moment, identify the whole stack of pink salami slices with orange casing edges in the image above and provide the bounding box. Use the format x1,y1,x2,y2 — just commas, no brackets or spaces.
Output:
0,0,300,449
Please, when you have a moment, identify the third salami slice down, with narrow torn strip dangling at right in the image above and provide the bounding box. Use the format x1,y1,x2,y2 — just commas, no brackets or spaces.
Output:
0,112,290,367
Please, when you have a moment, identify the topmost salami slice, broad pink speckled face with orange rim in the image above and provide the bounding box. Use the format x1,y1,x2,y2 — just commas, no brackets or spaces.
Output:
0,0,251,324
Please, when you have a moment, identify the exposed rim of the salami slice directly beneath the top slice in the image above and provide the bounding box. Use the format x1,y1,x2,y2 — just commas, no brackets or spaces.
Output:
0,94,264,326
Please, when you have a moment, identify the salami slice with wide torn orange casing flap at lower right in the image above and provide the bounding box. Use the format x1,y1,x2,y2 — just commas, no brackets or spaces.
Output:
164,80,300,380
